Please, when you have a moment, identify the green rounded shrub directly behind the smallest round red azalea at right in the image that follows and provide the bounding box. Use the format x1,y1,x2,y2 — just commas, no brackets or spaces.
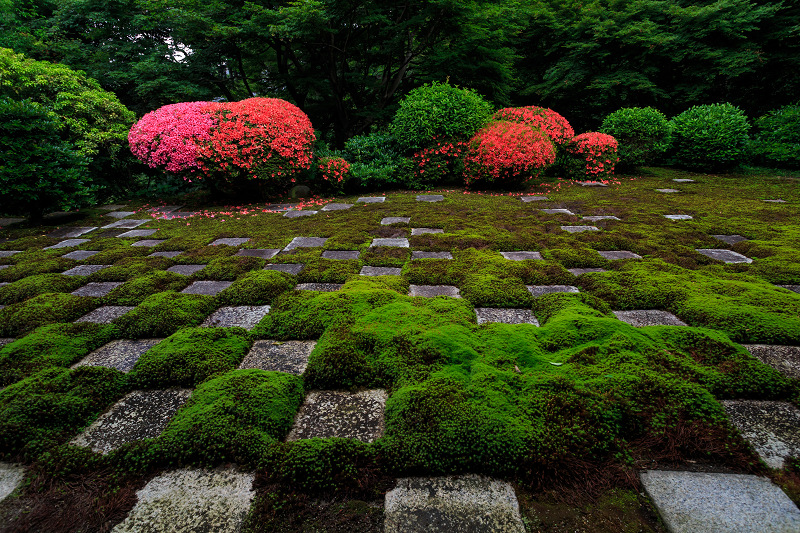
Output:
600,107,672,168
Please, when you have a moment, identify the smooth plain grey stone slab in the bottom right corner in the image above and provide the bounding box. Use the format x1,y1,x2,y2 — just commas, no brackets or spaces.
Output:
640,470,800,533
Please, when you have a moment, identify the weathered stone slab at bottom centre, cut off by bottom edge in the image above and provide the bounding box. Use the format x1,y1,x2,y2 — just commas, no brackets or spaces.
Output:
384,474,526,533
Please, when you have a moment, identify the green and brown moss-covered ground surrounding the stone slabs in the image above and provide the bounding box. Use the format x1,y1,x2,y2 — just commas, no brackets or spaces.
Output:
0,168,800,532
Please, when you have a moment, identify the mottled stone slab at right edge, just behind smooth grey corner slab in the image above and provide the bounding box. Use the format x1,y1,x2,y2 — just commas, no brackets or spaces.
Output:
720,400,800,470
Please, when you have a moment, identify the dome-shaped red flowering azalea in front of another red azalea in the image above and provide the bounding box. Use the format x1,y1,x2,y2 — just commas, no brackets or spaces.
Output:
464,122,556,186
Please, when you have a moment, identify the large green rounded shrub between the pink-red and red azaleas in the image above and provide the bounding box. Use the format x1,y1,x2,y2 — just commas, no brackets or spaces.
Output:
389,82,492,152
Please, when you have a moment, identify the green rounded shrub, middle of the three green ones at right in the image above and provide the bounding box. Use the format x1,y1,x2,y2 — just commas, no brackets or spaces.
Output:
672,103,750,171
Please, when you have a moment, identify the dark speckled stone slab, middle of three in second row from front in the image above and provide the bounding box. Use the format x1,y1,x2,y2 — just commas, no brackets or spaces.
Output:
286,389,388,442
